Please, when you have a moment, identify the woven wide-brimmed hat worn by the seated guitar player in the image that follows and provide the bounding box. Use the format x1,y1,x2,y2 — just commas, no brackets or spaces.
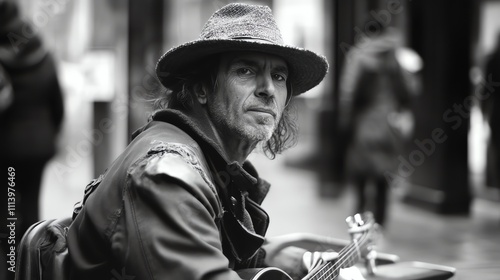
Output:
156,3,328,95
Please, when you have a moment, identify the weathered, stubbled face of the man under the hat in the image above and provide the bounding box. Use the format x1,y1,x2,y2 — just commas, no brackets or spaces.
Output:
207,52,288,143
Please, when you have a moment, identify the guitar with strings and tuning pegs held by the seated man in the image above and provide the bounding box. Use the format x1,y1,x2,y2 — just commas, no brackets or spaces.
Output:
238,212,379,280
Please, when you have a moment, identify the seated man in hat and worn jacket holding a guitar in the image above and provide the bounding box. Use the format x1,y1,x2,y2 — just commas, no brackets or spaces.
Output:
67,4,362,280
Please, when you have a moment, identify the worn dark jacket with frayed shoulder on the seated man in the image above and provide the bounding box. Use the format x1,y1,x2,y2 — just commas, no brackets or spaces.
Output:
67,110,269,280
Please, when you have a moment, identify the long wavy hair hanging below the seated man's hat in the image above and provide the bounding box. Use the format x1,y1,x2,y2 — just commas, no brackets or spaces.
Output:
148,55,298,159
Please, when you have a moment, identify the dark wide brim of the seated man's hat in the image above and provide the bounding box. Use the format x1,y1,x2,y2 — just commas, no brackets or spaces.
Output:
156,39,328,95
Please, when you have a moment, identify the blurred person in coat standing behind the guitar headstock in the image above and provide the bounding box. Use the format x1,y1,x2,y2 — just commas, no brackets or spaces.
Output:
339,25,421,225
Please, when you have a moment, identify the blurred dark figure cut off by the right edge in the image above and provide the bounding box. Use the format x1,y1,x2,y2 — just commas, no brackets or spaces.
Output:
481,32,500,188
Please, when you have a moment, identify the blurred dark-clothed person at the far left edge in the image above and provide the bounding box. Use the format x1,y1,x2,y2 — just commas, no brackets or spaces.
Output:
0,0,64,279
